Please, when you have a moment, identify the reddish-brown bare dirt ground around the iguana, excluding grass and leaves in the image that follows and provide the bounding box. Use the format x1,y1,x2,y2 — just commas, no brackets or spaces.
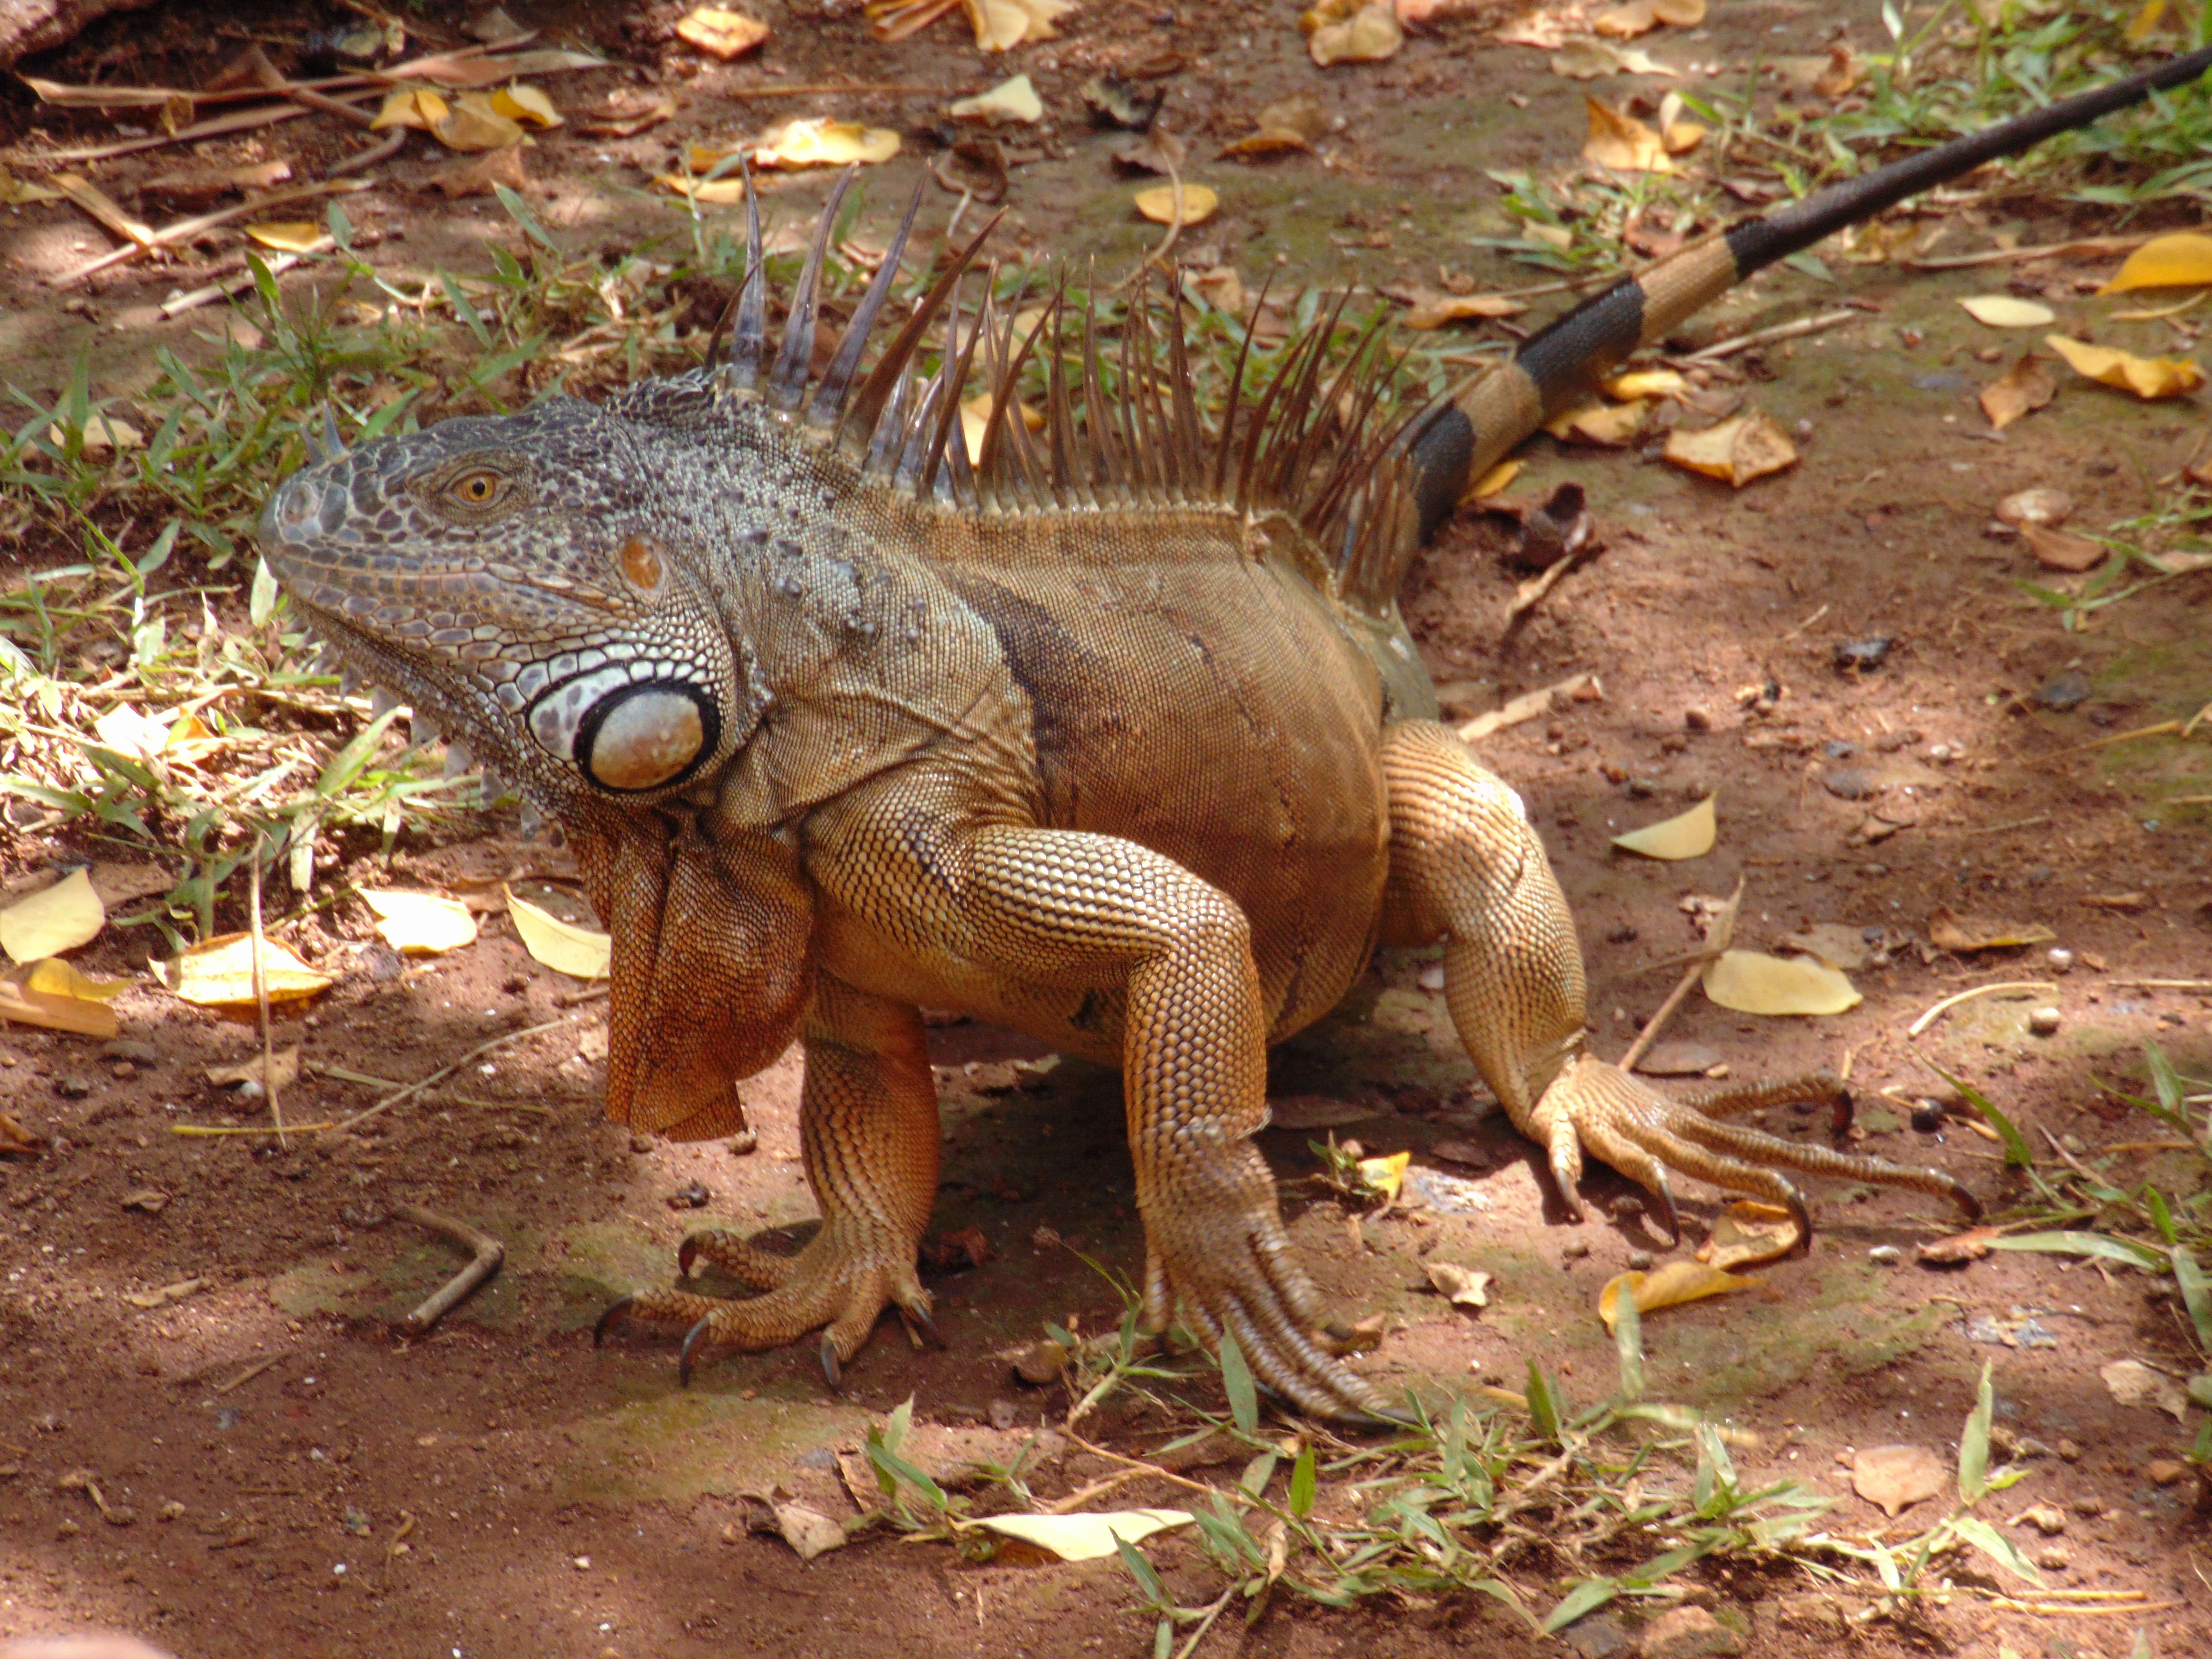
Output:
0,0,2212,1659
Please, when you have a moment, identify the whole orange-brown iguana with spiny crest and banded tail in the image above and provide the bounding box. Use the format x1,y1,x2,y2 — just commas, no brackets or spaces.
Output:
261,51,2212,1416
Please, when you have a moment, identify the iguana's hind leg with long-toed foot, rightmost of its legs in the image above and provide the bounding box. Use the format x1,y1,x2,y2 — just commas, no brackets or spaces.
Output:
1382,721,1980,1237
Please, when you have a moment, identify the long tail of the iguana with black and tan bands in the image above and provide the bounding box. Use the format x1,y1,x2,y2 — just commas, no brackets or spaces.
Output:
1376,46,2212,566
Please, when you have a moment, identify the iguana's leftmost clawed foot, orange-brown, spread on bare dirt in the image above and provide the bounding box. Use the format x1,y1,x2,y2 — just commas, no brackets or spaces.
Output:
593,1228,936,1387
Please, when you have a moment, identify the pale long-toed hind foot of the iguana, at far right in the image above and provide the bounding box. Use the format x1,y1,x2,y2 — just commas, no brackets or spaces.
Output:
1535,1055,1982,1239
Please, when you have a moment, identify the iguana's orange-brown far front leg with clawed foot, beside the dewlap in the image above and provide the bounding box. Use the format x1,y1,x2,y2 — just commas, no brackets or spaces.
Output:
599,975,938,1382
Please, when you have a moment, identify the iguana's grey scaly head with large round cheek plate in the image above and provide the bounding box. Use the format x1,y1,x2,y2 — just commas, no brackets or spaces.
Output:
261,398,757,818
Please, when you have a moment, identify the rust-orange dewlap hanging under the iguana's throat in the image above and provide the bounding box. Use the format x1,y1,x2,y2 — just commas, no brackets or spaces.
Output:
573,820,814,1141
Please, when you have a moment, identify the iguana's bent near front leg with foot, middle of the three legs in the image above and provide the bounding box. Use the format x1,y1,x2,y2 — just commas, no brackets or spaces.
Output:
807,779,1387,1416
